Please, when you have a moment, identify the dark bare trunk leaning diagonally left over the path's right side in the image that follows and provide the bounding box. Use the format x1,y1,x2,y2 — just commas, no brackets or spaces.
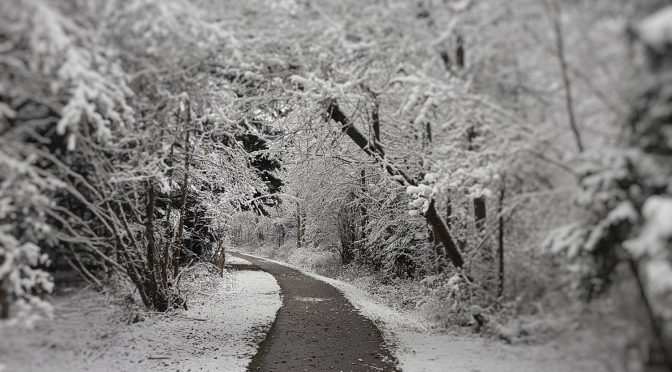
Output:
327,99,464,267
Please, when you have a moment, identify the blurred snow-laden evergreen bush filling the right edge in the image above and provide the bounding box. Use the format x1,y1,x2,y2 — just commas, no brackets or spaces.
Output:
544,7,672,367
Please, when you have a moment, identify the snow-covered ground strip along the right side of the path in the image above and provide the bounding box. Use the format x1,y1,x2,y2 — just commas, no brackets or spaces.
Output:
239,253,607,372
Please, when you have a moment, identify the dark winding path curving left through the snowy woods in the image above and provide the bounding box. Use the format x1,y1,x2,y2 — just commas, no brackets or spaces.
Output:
230,253,398,372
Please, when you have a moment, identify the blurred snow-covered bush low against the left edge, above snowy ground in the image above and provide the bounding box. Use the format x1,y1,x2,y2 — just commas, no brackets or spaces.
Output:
0,155,59,325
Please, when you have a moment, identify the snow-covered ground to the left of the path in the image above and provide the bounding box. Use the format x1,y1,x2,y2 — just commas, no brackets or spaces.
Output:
0,264,282,372
